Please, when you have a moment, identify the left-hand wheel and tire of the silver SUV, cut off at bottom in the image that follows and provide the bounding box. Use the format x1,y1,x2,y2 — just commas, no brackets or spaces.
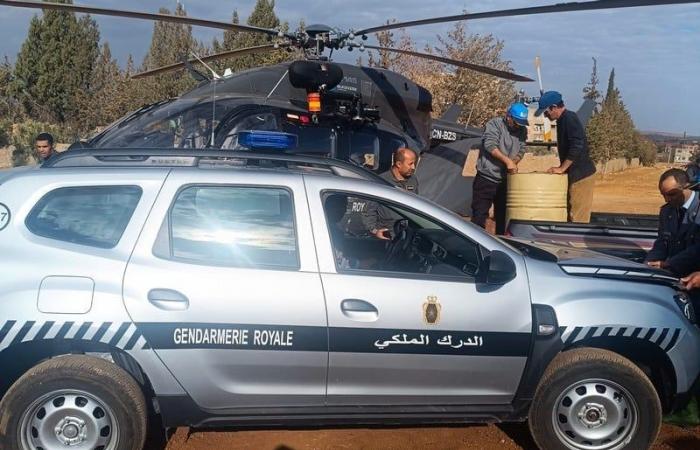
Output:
0,355,147,450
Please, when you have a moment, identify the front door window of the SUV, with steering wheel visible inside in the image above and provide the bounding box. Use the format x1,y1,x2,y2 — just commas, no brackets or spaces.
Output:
323,192,482,280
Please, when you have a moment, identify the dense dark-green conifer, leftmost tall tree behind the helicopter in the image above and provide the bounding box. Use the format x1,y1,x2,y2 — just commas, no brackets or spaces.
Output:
13,0,100,123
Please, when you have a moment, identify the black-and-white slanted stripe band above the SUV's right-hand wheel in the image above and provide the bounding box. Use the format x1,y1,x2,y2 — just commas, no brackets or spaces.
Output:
559,325,681,352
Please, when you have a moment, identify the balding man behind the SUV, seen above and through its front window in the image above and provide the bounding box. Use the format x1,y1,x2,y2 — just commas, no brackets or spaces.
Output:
364,147,418,239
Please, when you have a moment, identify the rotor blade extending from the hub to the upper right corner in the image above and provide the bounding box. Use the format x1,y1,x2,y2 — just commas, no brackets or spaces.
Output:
353,0,700,36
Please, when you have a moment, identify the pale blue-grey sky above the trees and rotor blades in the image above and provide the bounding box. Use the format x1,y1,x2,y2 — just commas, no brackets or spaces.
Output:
0,0,700,135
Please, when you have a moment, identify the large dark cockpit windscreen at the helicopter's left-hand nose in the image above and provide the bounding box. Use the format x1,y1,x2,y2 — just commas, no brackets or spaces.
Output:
95,99,235,148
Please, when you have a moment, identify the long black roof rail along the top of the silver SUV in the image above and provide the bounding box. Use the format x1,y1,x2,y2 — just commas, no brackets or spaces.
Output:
41,148,391,185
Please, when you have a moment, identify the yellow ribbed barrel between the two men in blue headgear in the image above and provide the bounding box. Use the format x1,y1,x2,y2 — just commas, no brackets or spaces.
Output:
506,173,568,223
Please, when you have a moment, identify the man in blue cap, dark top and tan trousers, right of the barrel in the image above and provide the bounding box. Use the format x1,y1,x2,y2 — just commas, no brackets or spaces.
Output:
535,91,595,223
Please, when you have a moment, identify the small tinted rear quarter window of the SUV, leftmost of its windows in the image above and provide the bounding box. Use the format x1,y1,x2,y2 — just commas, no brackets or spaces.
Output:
25,186,142,248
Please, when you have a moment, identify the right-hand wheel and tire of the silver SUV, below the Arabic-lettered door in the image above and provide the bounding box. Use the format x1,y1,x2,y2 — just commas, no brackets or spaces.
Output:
529,348,661,450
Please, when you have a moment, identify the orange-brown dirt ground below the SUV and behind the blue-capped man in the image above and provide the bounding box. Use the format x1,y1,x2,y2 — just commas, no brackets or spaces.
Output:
160,167,700,450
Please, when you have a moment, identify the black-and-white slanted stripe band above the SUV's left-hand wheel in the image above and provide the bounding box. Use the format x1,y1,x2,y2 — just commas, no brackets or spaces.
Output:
0,320,150,351
